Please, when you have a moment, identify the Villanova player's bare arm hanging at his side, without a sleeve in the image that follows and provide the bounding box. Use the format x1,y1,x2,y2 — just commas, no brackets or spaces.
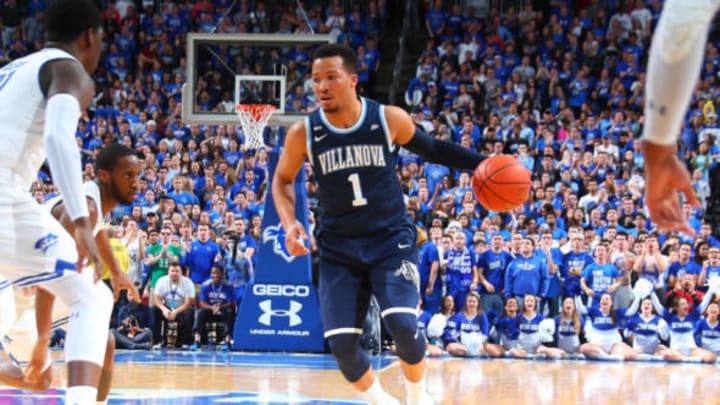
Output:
272,120,309,256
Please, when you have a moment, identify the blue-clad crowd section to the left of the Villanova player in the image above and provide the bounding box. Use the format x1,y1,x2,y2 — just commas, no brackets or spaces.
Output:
0,0,387,348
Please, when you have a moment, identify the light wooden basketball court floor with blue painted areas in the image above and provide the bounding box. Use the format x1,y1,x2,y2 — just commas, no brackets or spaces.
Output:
0,351,720,405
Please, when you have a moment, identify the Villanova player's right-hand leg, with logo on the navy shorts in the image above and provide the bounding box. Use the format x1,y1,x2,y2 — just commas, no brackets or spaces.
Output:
370,256,432,404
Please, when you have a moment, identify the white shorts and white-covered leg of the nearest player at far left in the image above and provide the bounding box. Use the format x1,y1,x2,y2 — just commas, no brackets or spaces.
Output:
0,197,113,404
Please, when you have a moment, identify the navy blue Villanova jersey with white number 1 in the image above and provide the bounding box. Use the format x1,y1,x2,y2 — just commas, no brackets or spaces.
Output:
305,98,410,236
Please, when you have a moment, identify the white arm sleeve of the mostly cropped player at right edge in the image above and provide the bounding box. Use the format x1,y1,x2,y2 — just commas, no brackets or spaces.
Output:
644,0,720,144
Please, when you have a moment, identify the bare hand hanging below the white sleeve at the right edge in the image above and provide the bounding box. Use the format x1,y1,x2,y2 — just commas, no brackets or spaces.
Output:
643,141,701,236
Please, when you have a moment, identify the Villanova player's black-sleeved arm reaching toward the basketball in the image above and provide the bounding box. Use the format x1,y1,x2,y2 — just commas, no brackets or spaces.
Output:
385,106,485,171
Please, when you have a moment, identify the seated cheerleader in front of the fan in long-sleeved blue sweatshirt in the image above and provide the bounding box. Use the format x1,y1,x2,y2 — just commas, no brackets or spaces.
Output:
509,294,565,359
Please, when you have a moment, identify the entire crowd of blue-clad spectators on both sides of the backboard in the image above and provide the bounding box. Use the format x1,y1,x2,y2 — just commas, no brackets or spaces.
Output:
9,0,720,360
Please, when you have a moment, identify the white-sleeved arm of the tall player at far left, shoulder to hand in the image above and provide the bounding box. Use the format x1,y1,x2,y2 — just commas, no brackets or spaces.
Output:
40,59,100,267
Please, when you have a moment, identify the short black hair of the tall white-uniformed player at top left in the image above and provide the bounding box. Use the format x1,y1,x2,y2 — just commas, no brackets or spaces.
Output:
45,0,102,42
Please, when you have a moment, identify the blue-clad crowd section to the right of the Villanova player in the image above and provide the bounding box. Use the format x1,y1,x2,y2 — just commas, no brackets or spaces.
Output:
398,0,720,361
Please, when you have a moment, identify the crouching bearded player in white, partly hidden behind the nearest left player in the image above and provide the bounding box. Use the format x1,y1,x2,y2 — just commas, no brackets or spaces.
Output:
0,144,141,402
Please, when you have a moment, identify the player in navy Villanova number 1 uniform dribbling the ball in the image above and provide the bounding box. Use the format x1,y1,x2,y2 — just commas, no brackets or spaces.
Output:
272,45,484,405
